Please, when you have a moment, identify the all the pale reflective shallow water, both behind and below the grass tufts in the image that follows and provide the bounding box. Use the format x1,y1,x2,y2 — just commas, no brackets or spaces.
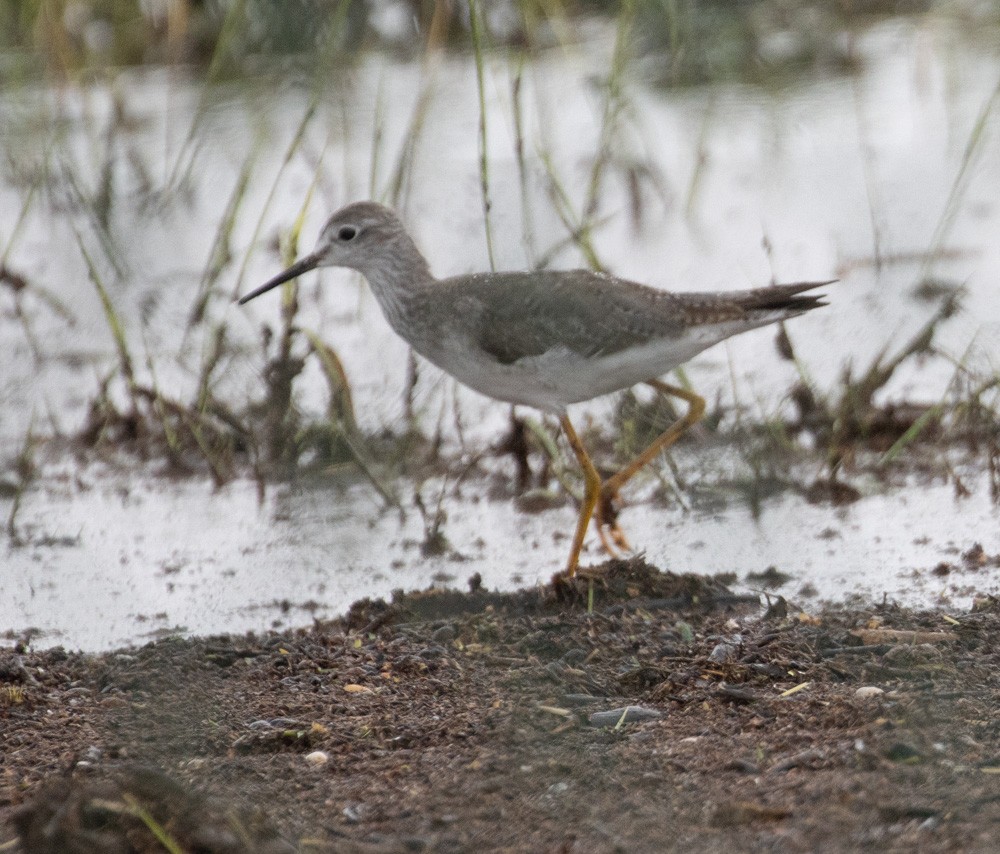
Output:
0,18,1000,648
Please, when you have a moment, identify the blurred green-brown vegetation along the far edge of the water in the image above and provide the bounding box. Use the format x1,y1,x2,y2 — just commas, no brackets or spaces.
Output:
0,0,1000,86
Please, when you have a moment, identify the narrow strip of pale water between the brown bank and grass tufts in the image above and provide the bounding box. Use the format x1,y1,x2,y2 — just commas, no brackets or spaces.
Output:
7,458,1000,649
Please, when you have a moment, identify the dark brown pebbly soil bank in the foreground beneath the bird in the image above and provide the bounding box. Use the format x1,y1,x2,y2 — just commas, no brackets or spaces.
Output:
0,561,1000,852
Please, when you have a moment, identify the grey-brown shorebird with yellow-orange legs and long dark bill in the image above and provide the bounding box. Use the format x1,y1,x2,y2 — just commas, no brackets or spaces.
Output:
239,202,831,577
